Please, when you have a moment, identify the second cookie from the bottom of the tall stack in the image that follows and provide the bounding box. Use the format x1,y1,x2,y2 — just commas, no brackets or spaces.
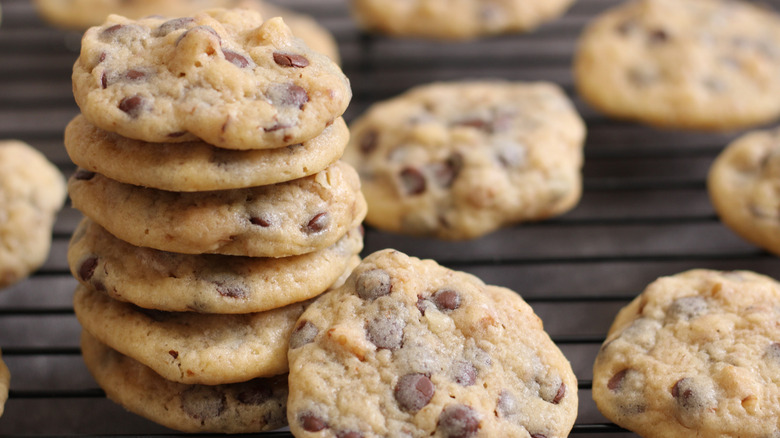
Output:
73,285,308,385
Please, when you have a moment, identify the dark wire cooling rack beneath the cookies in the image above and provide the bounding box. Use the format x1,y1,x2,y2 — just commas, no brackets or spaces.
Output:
0,0,780,437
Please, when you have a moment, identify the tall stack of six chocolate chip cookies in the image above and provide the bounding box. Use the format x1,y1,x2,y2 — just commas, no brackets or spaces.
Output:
65,9,366,433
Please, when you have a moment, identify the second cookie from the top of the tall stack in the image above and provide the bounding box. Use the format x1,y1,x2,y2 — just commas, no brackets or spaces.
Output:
65,115,349,192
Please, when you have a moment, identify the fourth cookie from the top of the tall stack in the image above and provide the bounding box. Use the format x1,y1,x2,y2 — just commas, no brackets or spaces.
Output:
68,219,363,314
